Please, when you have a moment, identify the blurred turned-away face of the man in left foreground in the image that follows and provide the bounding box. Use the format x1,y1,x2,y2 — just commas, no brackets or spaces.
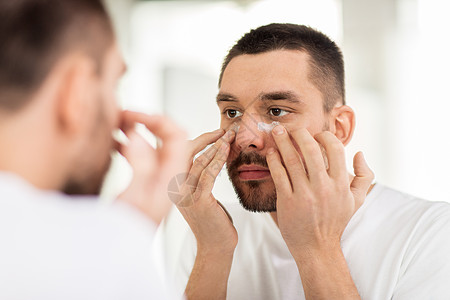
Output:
64,45,125,194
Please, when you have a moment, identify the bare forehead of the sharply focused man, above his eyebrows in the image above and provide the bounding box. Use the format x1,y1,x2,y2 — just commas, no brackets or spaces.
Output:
220,50,317,94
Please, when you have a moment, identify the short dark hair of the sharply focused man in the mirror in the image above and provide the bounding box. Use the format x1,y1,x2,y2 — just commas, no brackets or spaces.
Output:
219,23,345,112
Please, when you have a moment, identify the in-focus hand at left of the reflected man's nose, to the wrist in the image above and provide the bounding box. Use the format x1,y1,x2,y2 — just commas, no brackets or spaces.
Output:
176,130,238,256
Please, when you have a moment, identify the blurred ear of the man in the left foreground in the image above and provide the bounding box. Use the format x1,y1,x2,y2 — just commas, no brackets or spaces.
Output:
54,55,96,134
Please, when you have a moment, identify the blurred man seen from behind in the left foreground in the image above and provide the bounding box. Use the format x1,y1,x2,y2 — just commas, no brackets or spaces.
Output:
0,0,185,299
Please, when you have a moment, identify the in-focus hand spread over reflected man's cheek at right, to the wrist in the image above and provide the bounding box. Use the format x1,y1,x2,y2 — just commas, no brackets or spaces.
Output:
267,125,373,261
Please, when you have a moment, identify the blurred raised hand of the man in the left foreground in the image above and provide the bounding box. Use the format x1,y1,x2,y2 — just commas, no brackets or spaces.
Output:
117,111,187,224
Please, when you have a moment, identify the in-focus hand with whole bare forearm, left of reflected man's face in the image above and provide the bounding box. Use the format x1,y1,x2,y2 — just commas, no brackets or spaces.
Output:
174,130,238,300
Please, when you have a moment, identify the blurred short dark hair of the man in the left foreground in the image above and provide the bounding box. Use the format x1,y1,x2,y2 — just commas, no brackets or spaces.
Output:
0,0,113,111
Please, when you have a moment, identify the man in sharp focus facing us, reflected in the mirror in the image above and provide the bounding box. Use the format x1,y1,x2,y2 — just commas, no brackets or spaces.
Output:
161,24,450,300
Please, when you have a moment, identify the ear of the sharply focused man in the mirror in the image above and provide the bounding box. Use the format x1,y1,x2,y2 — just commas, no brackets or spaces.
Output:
330,105,355,146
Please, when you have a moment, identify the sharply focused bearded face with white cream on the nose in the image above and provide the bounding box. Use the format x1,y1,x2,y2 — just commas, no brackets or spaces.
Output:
217,50,328,212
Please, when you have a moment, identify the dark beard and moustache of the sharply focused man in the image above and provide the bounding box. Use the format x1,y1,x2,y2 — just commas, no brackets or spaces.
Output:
227,152,277,212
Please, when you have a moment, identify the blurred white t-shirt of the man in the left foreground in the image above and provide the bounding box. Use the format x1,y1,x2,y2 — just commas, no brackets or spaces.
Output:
0,172,177,300
